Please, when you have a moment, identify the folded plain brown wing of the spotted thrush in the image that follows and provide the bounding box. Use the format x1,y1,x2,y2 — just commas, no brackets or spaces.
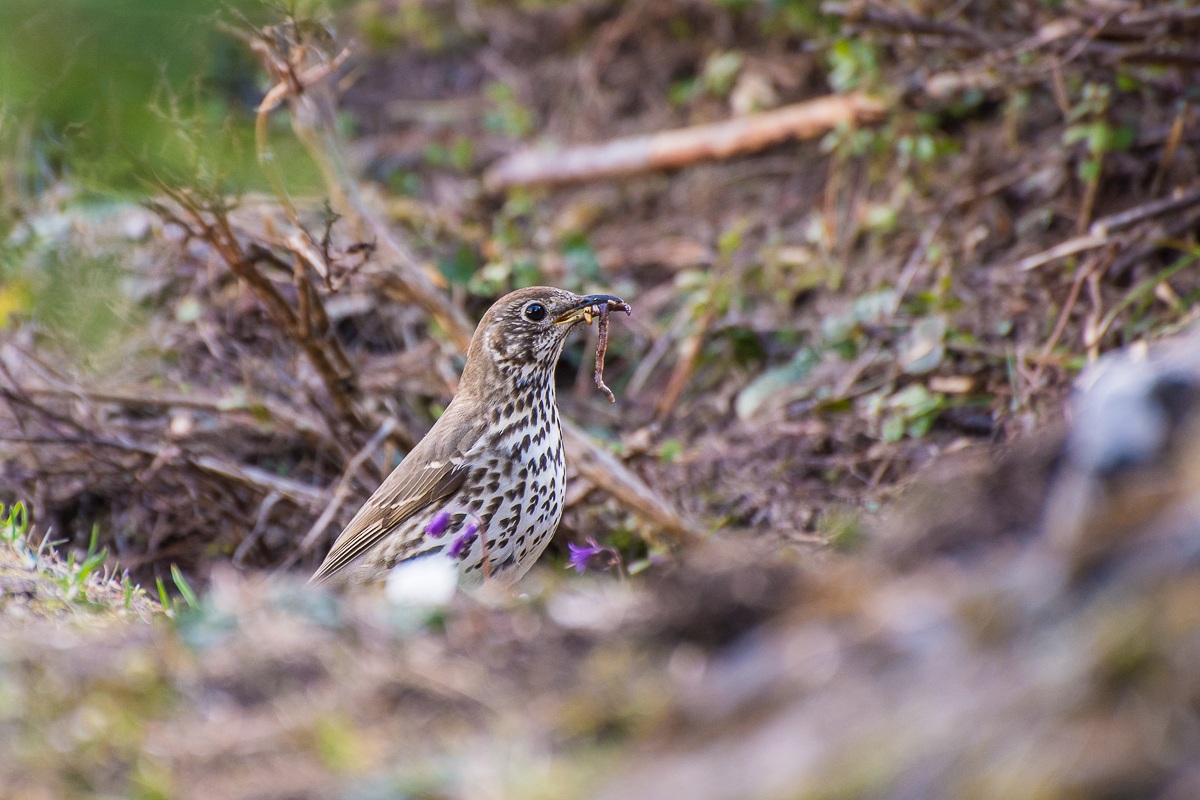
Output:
310,408,484,583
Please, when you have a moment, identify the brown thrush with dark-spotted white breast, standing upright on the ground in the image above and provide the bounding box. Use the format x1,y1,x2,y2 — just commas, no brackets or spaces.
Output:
310,287,629,590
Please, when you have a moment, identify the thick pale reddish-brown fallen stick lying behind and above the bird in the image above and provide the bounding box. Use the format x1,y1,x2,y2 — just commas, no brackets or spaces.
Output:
484,94,886,192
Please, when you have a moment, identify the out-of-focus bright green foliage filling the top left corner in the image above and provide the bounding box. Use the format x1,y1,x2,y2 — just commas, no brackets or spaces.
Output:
0,0,328,194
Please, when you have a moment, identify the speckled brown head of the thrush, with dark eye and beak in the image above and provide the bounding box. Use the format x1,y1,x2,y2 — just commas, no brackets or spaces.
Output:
463,287,624,385
